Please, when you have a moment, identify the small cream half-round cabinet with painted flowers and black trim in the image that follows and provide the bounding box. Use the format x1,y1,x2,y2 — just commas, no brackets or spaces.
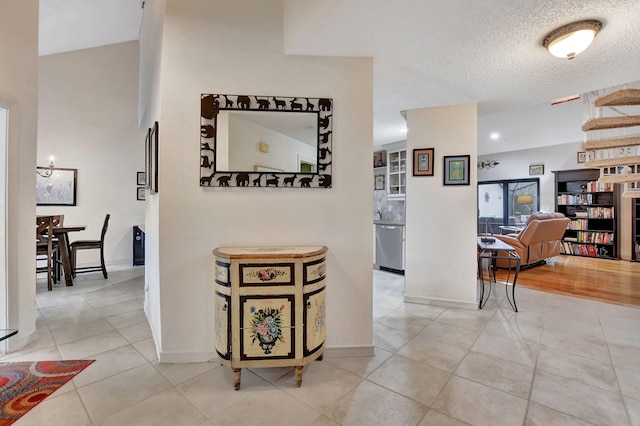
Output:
213,246,327,390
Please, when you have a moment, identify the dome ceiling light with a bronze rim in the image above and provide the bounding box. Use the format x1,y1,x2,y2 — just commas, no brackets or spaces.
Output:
542,19,602,59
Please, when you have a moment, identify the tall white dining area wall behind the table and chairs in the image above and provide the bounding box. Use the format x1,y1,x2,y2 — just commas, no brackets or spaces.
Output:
37,41,146,270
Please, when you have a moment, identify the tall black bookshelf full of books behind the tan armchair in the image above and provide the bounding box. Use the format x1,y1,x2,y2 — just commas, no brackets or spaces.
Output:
553,169,620,259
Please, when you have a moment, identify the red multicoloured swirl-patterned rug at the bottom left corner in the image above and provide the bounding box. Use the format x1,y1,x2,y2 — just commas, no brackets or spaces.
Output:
0,360,94,426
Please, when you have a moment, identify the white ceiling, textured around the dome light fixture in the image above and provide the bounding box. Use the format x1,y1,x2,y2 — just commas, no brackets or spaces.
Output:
40,0,640,154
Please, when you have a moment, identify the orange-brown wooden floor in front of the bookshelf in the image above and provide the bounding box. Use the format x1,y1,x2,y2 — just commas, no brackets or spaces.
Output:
498,255,640,307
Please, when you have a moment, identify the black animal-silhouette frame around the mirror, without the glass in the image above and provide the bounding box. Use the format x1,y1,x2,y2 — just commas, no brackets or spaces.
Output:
200,93,333,188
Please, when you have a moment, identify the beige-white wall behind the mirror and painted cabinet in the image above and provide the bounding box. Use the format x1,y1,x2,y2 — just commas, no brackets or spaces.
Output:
142,0,373,362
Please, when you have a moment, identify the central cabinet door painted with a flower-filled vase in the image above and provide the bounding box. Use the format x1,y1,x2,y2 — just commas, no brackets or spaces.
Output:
240,295,295,360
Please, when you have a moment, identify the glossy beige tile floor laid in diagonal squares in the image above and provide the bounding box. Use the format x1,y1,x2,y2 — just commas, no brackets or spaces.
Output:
5,269,640,426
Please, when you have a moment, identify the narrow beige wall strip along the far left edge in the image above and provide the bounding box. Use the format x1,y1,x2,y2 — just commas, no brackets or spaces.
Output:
0,0,38,350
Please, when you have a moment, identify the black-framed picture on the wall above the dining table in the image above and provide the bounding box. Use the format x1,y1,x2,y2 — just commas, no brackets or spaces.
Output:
36,167,78,206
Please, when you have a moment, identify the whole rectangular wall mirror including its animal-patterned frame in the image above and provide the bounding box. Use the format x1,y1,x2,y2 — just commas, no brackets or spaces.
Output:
200,94,333,188
